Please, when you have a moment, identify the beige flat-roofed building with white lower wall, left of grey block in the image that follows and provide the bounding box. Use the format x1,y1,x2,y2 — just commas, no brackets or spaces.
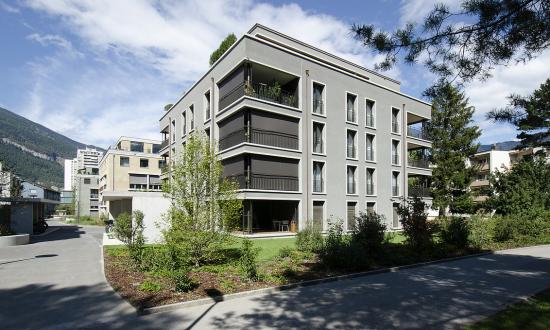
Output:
99,136,169,241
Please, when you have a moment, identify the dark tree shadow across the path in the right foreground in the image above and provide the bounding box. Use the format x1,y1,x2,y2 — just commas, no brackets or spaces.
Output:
200,254,550,329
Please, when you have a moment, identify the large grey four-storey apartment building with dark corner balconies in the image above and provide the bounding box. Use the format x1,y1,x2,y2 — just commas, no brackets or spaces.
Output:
160,24,431,233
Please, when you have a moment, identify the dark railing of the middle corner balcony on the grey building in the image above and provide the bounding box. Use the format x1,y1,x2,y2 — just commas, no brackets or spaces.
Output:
219,127,298,150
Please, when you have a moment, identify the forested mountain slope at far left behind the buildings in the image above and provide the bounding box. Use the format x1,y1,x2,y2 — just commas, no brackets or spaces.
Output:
0,108,100,187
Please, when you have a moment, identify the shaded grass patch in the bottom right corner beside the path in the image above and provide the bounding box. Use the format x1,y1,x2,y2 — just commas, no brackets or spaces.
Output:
466,289,550,330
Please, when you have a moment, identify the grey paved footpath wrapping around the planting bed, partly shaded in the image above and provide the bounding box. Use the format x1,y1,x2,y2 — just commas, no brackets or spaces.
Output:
0,220,550,329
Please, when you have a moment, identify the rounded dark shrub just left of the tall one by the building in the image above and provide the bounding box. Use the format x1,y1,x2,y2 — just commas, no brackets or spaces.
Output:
351,212,386,253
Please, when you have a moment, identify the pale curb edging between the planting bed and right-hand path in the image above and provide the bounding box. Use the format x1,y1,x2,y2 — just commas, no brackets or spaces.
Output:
137,251,495,315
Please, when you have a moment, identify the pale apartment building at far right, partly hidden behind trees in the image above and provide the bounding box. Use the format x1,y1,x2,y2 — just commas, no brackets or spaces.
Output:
469,141,543,202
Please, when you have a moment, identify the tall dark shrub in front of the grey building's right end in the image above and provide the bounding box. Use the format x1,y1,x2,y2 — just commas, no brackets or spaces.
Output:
397,196,436,252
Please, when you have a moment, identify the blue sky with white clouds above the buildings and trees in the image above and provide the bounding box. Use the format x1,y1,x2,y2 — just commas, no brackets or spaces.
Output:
0,0,550,147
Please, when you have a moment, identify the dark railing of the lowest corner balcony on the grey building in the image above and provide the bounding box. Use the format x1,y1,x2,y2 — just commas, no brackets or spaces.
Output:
228,173,298,191
